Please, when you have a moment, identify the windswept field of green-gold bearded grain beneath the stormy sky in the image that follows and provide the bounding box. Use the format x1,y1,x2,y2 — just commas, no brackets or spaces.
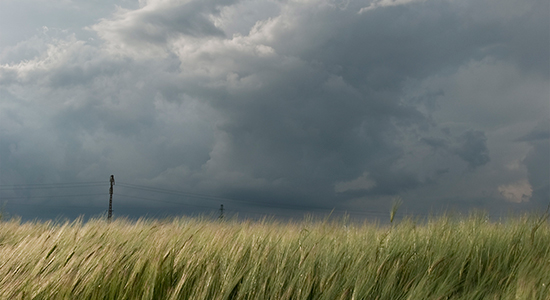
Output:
0,214,550,300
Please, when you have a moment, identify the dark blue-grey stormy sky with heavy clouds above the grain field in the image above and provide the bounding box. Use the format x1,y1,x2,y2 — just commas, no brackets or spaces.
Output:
0,0,550,219
